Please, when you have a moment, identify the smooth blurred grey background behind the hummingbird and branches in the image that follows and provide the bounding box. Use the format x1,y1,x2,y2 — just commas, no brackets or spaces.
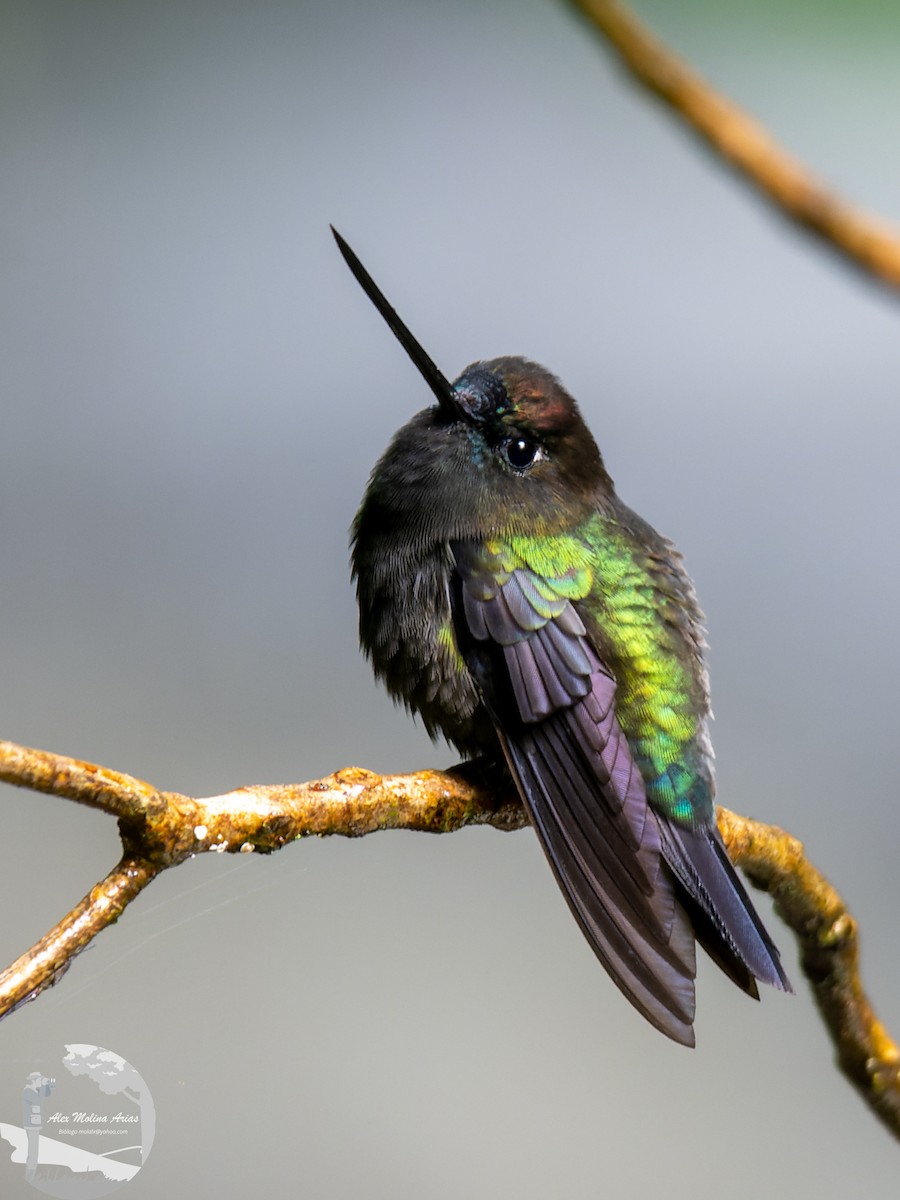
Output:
0,0,900,1200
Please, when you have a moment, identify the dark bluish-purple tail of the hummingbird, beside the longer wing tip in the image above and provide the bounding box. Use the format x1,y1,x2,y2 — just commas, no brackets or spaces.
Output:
658,816,793,998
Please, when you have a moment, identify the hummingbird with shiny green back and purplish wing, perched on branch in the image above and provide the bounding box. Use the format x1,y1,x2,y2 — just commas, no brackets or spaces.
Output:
331,227,792,1046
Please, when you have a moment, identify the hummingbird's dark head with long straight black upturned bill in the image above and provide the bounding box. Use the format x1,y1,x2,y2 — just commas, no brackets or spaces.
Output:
332,230,612,538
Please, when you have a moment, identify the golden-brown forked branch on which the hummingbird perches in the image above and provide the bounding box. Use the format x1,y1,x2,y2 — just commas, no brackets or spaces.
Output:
0,742,900,1138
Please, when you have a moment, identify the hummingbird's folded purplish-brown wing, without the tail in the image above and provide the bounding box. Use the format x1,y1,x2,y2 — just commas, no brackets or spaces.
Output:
460,548,696,1045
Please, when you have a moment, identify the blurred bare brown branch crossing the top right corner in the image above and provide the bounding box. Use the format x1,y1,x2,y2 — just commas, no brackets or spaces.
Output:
572,0,900,288
